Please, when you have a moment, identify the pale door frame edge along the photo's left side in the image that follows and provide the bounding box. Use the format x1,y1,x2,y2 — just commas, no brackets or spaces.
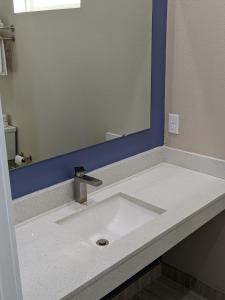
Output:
0,101,22,300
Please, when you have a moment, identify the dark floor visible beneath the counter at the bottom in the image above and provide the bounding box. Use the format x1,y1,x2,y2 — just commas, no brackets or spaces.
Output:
130,276,206,300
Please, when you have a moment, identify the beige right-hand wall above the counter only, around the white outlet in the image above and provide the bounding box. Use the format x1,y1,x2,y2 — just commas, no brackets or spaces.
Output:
166,0,225,159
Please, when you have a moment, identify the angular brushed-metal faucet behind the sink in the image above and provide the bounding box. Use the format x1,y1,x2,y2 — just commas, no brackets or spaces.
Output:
74,167,103,203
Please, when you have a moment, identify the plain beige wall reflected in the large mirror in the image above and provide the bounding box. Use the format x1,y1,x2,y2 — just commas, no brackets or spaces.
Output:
0,0,151,163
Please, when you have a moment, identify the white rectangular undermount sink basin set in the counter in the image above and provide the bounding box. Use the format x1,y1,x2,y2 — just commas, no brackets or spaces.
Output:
56,193,165,244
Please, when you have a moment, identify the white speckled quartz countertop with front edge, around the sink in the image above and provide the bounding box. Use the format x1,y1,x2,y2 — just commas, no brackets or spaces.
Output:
16,163,225,300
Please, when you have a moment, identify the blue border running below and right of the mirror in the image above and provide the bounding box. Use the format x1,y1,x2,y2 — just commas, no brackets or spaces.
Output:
10,0,167,199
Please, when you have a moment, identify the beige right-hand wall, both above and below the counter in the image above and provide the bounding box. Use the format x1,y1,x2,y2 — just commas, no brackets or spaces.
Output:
164,0,225,293
